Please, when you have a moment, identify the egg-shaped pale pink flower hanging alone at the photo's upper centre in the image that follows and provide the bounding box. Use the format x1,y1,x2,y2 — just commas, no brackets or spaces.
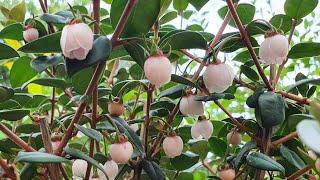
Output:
144,55,172,88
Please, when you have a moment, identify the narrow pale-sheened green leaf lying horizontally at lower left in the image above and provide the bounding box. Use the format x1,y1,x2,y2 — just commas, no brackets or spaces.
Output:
15,152,69,164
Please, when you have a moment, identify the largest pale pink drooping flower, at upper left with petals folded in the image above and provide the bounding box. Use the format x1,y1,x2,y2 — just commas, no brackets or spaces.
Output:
60,23,93,60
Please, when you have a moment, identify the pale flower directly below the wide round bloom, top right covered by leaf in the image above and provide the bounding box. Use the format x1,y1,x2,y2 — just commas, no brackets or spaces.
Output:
179,94,204,116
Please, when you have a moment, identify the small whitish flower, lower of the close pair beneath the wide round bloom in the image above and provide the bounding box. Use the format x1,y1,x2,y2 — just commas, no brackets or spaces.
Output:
191,119,213,140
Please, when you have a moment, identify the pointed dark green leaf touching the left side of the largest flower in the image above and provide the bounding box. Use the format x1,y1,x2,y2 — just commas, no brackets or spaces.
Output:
18,31,61,53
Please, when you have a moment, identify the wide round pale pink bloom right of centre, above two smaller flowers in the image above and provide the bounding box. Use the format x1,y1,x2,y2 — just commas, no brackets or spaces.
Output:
203,63,235,93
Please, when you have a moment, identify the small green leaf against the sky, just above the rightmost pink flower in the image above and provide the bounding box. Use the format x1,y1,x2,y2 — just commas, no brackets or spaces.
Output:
269,14,292,33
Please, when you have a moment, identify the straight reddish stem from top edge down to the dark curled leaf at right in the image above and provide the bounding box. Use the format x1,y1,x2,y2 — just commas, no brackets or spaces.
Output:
227,0,273,91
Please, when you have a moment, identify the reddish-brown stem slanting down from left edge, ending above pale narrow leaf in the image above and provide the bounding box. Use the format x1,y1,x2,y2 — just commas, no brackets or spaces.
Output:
0,123,36,152
